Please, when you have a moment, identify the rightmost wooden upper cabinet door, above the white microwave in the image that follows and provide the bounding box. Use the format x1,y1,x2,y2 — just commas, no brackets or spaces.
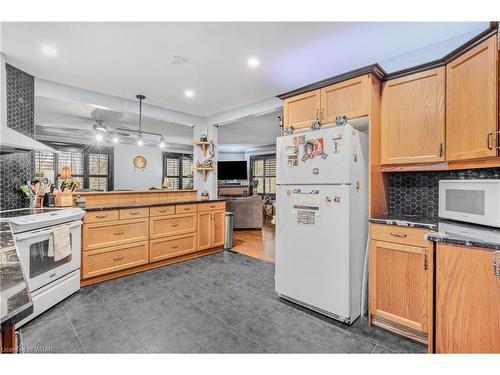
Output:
446,36,498,161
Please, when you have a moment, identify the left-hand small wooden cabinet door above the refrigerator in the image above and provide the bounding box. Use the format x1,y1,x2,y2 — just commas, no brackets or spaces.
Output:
283,90,321,129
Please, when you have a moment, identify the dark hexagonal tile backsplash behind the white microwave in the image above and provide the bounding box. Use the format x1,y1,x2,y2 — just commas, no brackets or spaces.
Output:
389,168,500,218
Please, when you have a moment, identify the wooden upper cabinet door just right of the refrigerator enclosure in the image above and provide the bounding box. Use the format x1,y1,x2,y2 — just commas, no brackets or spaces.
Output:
381,67,445,164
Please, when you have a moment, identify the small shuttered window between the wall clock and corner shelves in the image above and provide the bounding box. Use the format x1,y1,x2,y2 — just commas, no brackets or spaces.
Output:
163,152,194,190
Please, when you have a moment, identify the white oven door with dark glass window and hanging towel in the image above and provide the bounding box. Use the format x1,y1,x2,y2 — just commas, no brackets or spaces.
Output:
14,220,82,291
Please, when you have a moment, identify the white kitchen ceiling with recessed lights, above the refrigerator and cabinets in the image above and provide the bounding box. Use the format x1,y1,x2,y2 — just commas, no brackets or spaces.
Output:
1,22,488,116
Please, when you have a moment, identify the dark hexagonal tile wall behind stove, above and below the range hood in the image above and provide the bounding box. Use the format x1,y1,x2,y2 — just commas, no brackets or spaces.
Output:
0,64,35,210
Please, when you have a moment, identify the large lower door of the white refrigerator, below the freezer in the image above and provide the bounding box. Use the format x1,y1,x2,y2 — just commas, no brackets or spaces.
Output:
275,185,350,318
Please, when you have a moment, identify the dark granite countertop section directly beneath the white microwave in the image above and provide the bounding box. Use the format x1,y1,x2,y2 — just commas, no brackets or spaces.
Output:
426,220,500,250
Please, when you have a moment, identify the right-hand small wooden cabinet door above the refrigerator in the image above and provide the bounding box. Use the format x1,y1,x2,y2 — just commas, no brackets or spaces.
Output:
320,75,370,124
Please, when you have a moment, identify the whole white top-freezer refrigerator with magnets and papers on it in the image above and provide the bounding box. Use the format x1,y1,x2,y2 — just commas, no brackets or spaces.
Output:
275,124,368,324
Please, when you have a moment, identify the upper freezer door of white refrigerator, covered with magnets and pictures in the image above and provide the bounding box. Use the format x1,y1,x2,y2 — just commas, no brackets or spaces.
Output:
276,125,357,185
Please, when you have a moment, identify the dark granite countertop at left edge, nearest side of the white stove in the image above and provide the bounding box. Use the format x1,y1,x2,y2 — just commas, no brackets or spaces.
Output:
0,221,33,330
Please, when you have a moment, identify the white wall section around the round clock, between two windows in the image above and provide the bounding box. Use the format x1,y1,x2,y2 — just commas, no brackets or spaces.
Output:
114,145,171,190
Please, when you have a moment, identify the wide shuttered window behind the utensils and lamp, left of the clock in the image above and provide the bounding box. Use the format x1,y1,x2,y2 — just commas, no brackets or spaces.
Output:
35,143,113,191
